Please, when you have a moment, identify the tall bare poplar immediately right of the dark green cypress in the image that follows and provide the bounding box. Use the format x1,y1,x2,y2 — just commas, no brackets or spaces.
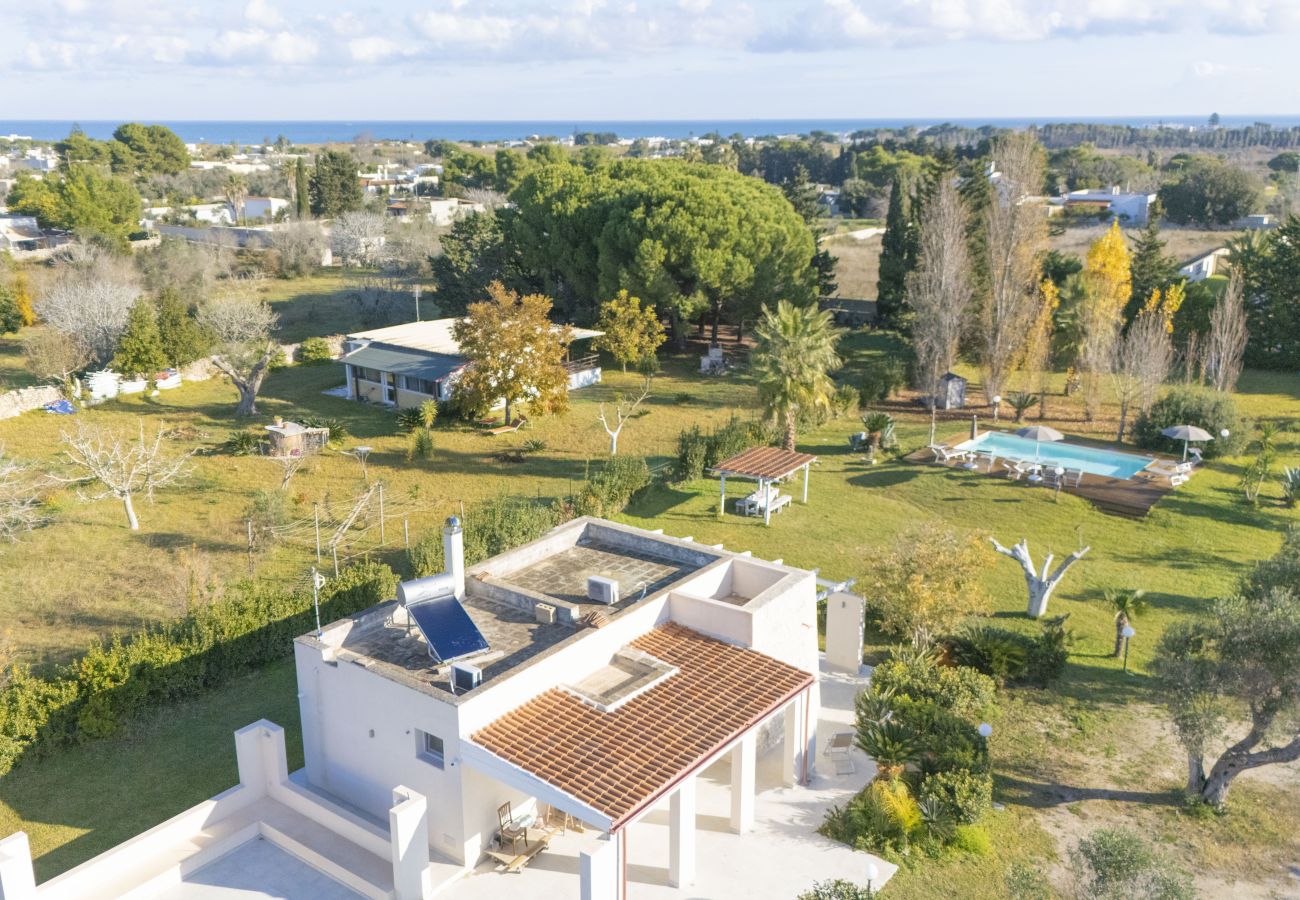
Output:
906,174,972,406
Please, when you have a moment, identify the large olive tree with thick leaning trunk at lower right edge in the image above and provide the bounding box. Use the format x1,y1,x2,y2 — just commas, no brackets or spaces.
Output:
1154,532,1300,806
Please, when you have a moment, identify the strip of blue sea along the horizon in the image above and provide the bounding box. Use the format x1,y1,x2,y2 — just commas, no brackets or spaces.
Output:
0,113,1300,144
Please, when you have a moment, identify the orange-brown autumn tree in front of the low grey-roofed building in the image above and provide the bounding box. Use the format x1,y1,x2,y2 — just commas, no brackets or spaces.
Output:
452,281,573,424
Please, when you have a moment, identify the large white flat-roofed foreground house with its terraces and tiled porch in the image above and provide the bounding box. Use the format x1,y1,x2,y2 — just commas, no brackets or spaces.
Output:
0,518,893,900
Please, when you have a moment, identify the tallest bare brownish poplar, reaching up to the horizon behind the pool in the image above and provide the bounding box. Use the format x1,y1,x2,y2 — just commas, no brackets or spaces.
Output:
980,131,1048,399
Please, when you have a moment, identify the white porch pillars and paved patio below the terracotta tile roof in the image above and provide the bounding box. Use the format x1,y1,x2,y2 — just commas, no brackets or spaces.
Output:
452,652,893,900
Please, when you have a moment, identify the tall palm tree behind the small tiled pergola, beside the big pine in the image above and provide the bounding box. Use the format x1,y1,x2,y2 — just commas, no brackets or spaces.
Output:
753,300,841,450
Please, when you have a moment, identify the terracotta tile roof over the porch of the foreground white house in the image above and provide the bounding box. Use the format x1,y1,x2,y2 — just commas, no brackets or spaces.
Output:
473,622,814,826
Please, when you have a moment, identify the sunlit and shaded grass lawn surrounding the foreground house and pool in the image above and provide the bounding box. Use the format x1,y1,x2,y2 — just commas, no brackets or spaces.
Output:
0,314,1300,897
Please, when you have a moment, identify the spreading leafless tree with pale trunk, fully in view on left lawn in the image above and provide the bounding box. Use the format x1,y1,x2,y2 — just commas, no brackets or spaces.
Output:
51,423,194,531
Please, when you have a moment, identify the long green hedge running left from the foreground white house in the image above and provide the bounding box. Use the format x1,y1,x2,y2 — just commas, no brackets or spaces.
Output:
0,562,395,775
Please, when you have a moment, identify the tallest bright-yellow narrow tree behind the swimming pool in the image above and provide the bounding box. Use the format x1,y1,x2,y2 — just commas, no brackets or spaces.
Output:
1079,218,1132,421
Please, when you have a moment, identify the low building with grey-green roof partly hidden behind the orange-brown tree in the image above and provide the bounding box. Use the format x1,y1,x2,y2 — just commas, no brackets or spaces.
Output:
339,319,603,410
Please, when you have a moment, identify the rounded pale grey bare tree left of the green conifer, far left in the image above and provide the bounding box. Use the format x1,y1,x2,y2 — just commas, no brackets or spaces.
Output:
35,258,140,364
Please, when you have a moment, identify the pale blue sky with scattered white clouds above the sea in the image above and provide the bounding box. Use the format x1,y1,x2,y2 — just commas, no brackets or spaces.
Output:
0,0,1300,121
